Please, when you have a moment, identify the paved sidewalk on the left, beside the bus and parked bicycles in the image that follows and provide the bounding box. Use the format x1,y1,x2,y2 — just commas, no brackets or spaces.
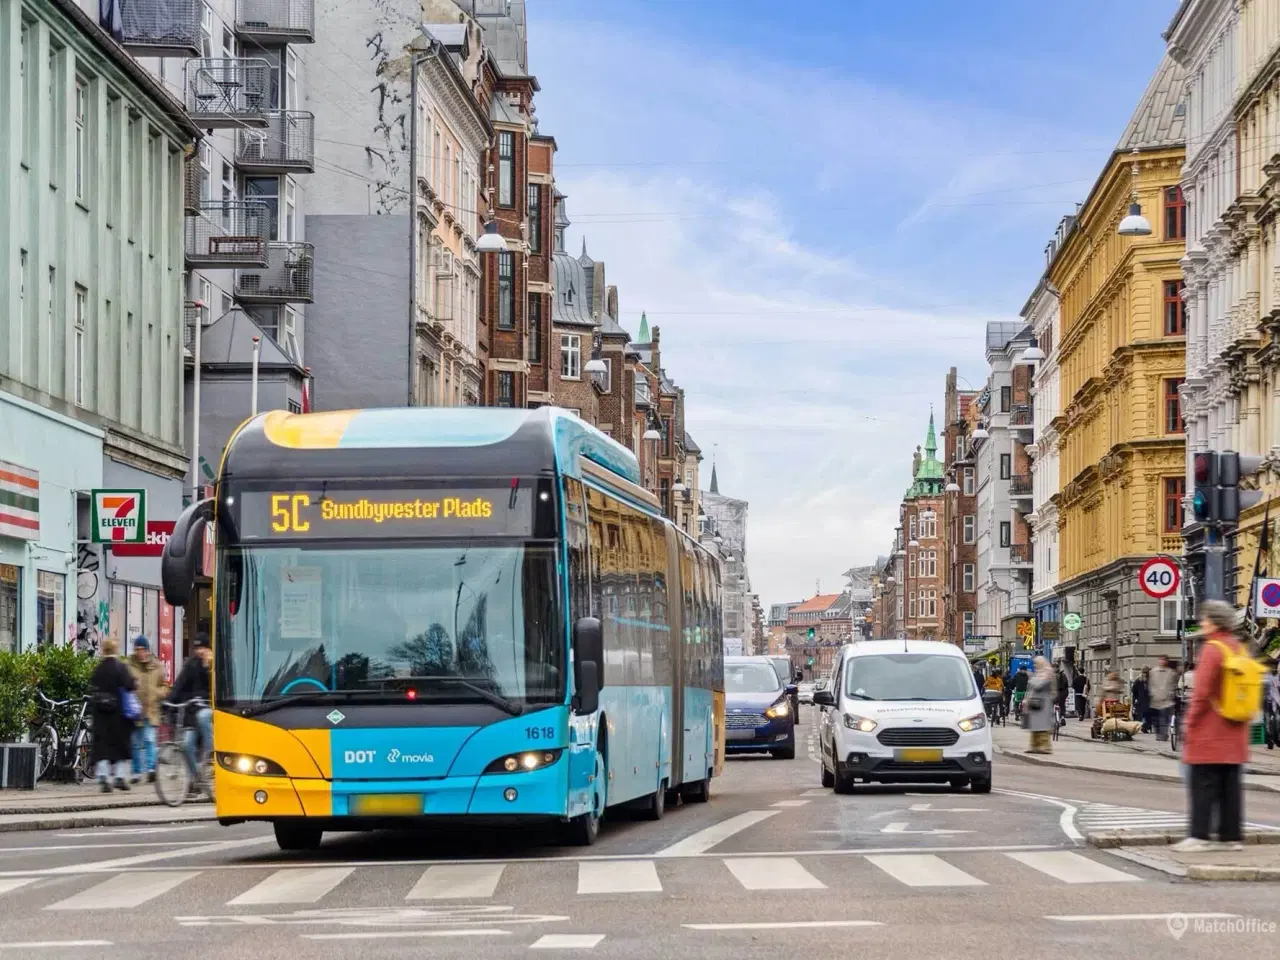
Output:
0,782,214,833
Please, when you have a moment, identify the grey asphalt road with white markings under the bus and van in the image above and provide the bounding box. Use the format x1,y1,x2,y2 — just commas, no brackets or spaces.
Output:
0,708,1280,960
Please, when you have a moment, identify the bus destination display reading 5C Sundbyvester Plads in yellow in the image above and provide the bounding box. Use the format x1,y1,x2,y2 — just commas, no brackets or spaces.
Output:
239,486,532,540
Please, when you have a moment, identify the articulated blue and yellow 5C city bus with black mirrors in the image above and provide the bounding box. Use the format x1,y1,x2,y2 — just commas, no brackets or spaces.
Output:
161,407,724,850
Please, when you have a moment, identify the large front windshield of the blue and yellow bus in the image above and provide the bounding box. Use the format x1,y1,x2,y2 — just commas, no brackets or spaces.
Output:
215,541,564,708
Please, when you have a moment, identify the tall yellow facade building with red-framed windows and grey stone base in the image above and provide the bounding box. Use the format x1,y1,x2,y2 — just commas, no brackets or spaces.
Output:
1048,59,1185,689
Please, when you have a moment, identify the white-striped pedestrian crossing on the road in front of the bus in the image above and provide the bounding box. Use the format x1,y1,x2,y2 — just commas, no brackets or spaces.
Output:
0,850,1143,913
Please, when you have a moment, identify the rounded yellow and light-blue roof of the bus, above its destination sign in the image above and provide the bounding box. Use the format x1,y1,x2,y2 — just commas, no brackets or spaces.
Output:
221,407,640,484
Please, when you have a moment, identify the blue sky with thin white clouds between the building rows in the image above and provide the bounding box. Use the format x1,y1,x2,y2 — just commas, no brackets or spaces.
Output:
529,0,1176,604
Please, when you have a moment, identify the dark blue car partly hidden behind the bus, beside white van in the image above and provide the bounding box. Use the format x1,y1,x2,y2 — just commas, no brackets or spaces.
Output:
724,657,796,760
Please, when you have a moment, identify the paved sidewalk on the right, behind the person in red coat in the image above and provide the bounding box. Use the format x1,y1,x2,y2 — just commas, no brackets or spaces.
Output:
991,721,1280,792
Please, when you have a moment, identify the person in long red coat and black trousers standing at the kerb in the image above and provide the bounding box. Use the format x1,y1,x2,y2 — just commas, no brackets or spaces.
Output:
1174,600,1249,851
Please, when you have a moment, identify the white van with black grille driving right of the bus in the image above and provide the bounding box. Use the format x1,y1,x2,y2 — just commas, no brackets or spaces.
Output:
813,640,992,794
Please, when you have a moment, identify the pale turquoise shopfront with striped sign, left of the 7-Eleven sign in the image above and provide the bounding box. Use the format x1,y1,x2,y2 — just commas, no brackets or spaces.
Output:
0,393,102,652
